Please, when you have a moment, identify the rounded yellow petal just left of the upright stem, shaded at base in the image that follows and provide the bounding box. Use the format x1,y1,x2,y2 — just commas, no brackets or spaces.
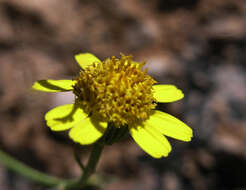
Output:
69,117,107,145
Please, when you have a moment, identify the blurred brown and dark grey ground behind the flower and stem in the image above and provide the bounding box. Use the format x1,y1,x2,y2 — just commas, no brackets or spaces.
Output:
0,0,246,190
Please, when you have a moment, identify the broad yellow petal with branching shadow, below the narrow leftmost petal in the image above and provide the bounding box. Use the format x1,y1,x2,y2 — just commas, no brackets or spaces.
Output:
45,104,87,131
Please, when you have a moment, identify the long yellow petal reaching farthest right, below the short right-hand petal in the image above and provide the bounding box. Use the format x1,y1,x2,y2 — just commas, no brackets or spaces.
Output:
145,110,193,141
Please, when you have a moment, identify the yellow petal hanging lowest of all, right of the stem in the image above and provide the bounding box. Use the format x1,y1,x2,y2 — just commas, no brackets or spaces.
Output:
129,125,171,158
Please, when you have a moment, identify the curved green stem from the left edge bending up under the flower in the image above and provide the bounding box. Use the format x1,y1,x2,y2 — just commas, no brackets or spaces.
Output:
0,141,104,190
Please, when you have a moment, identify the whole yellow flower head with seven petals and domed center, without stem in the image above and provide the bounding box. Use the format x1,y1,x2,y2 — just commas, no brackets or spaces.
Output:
33,53,192,158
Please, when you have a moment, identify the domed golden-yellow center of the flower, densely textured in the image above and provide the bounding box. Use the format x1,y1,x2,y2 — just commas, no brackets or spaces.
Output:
73,54,156,127
